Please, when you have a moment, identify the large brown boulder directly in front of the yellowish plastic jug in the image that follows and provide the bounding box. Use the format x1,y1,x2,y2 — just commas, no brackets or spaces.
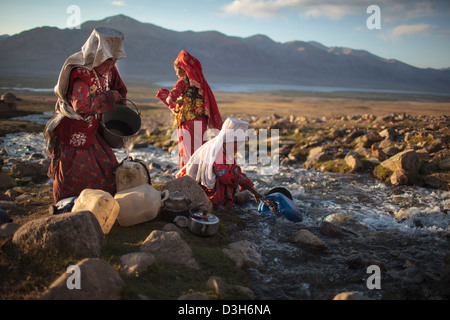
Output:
13,211,105,257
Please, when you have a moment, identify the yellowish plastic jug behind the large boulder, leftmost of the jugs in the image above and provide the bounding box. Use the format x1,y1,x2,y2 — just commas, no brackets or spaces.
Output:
72,189,119,234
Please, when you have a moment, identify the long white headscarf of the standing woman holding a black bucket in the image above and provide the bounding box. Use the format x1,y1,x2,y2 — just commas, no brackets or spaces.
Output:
44,27,125,154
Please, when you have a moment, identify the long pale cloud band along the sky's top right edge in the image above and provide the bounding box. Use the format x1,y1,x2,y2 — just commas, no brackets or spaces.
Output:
222,0,450,21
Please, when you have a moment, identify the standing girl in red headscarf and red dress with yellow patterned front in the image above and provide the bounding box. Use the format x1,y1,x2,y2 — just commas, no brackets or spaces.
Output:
156,50,222,168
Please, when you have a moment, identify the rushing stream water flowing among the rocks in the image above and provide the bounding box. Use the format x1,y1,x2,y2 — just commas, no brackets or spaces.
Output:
0,114,450,299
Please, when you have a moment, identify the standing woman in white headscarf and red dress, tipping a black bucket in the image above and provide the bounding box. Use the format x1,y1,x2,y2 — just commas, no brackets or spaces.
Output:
44,28,127,203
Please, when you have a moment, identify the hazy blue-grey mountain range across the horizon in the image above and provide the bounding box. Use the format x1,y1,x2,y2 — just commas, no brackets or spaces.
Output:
0,15,450,92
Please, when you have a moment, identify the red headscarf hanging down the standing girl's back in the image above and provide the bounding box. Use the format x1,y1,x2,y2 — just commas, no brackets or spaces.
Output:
174,50,222,130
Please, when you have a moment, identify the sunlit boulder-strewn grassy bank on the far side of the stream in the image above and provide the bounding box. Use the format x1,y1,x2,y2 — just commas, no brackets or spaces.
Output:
134,113,450,190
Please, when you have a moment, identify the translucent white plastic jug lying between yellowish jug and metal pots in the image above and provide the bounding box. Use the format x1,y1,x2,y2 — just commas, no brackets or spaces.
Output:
114,184,169,227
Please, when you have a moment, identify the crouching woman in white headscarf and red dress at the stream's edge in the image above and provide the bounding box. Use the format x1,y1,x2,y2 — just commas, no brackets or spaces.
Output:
177,118,263,209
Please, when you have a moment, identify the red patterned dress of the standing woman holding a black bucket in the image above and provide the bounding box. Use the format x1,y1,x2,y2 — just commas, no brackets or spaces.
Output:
49,67,127,203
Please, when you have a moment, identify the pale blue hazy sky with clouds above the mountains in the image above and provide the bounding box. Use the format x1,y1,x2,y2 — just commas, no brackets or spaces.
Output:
0,0,450,68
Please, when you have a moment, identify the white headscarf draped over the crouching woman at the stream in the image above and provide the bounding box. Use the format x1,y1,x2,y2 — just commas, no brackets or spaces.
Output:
180,118,248,189
